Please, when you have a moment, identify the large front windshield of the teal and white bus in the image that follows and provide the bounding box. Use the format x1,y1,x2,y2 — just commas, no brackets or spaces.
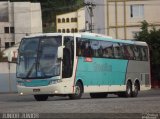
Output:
17,36,62,79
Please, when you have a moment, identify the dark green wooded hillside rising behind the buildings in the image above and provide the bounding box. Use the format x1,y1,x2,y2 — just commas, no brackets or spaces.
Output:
10,0,84,32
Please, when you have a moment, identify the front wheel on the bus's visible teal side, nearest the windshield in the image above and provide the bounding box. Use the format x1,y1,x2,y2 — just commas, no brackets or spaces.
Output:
68,82,83,99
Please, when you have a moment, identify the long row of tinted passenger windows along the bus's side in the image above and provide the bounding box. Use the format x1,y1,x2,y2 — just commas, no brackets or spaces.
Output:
77,38,148,61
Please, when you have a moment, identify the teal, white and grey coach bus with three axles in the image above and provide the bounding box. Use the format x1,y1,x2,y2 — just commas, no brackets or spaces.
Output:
16,32,151,101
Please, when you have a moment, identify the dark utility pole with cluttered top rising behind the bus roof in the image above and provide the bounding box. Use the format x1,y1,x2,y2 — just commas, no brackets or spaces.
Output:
84,2,96,33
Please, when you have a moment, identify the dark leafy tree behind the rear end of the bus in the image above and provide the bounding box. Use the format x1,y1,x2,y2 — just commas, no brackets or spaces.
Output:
135,21,160,80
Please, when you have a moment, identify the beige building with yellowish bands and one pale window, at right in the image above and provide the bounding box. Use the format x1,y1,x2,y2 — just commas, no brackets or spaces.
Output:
104,0,160,39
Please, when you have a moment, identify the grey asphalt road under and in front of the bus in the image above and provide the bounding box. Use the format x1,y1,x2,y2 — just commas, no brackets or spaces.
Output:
0,89,160,118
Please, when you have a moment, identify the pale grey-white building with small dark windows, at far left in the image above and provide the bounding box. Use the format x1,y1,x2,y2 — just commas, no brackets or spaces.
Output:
0,1,42,51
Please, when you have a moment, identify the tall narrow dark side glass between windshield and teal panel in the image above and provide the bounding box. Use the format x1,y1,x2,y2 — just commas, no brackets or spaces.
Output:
62,36,74,78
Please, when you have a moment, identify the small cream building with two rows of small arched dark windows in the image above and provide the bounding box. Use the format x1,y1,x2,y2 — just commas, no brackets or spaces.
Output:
56,8,85,33
